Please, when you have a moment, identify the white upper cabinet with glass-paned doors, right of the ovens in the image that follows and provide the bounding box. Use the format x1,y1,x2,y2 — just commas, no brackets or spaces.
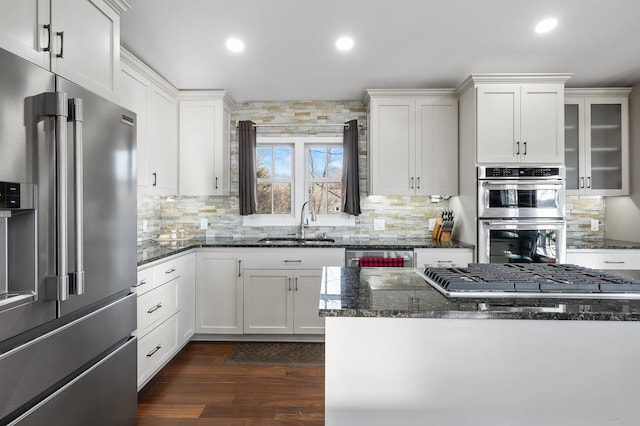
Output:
565,88,631,196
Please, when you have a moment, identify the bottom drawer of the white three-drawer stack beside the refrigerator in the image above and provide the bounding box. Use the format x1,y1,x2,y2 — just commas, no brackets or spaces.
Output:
138,315,178,390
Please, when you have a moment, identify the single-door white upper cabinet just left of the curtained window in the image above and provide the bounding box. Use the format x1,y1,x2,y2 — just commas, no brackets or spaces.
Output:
179,91,233,195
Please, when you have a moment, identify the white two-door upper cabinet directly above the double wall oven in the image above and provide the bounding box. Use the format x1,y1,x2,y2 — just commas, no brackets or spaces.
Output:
458,74,569,164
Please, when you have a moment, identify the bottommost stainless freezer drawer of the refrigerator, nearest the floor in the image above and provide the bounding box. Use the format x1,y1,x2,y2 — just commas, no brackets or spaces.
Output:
10,338,137,426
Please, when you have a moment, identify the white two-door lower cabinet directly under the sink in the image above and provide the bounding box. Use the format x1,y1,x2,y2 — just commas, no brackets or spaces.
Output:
243,248,344,334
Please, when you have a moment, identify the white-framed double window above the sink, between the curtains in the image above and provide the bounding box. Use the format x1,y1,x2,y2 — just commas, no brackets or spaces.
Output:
243,136,355,226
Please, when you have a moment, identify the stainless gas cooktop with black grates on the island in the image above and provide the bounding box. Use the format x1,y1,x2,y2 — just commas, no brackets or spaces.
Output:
421,263,640,299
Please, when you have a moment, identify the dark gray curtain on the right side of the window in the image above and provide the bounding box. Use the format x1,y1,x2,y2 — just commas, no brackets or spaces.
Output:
342,120,361,216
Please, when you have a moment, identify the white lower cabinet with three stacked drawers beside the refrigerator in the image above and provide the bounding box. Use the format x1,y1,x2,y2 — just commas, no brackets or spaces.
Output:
135,253,195,389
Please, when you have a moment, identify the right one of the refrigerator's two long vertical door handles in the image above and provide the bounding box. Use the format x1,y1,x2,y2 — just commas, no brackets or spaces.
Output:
67,98,84,295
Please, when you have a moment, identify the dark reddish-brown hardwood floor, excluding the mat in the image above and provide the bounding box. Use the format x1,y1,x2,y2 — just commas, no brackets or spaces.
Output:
138,342,324,426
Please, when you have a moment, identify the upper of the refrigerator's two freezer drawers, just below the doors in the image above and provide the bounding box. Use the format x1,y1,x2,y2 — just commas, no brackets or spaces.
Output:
0,294,136,424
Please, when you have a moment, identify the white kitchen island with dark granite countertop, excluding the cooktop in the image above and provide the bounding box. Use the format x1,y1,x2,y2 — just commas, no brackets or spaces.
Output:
320,268,640,425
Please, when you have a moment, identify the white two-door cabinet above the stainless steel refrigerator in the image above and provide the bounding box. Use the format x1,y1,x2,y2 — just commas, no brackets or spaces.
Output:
0,0,129,101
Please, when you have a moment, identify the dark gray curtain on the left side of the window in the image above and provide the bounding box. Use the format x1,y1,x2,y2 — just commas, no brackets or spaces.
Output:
238,121,258,216
